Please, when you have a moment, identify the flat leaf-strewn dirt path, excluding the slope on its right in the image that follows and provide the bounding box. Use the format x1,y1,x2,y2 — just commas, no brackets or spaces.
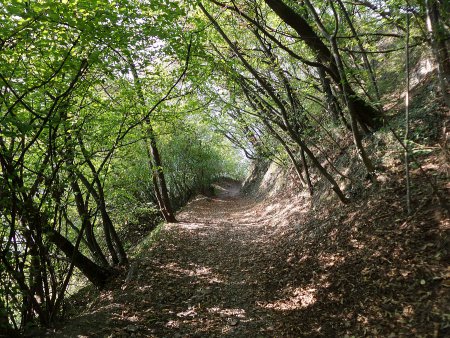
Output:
57,180,313,337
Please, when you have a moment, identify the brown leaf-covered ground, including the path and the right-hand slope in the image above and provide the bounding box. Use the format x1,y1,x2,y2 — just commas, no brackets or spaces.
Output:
51,174,450,337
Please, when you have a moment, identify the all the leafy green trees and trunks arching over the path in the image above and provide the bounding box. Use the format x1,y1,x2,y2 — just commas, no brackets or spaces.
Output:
0,0,450,332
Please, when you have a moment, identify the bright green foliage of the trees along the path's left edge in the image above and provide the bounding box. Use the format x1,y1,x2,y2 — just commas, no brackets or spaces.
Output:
0,0,207,329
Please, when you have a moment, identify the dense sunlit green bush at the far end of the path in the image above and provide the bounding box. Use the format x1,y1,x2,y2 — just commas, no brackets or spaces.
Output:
161,115,246,203
